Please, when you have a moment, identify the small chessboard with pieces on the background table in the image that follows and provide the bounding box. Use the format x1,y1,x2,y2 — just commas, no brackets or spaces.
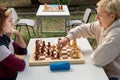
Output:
43,4,64,12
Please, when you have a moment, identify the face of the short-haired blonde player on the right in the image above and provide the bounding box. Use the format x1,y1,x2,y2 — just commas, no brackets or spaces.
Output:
96,7,115,29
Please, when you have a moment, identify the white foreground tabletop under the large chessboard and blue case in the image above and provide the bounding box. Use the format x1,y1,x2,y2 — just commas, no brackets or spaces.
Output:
17,37,108,80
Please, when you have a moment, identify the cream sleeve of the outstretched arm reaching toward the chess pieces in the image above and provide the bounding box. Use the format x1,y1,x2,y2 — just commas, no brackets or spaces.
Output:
66,21,100,40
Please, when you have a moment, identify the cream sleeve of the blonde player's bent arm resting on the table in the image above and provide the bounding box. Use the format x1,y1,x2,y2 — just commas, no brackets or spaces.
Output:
91,38,119,66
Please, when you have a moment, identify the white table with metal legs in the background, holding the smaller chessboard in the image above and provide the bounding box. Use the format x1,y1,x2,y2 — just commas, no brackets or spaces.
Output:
36,5,70,36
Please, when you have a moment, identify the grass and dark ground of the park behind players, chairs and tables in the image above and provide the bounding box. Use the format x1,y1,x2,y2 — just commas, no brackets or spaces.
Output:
0,0,99,49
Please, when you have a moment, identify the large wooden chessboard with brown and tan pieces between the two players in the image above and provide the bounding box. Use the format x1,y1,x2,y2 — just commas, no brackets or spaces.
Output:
29,39,84,66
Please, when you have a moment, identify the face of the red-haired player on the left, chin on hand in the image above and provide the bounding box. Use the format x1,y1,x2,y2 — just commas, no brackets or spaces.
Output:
3,13,13,33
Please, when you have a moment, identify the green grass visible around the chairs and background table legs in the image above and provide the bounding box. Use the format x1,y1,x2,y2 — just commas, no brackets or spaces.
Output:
12,14,96,48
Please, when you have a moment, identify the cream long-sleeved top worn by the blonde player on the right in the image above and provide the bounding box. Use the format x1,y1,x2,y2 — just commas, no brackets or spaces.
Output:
66,19,120,80
